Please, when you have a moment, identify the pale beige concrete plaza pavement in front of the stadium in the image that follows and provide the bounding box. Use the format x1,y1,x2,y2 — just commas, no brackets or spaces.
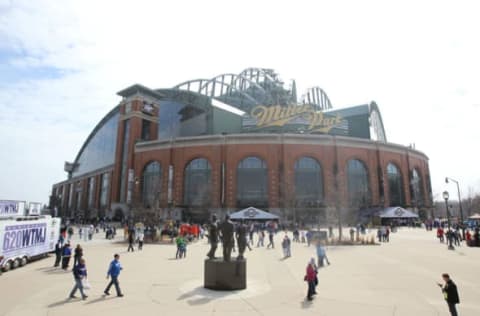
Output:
0,228,480,316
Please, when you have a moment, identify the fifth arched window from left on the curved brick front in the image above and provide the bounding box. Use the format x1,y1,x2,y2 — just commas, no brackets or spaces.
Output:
347,159,371,207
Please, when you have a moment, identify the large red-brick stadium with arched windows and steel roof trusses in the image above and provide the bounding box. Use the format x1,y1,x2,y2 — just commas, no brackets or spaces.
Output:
50,68,432,223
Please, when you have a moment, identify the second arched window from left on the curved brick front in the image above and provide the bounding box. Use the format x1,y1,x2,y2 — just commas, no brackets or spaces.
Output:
183,158,212,206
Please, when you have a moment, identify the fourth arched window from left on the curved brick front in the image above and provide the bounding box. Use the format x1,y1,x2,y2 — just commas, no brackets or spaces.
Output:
295,157,323,207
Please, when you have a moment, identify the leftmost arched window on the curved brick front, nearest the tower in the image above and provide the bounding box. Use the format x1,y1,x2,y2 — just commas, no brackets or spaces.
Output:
142,161,162,207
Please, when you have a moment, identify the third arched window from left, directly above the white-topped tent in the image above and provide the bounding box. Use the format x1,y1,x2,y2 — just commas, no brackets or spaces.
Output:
237,157,268,207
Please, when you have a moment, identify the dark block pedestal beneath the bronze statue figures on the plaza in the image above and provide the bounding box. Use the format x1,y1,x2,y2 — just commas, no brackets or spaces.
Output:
203,258,247,291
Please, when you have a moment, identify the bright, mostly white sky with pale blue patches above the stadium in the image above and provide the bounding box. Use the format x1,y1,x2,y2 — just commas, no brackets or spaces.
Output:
0,0,480,203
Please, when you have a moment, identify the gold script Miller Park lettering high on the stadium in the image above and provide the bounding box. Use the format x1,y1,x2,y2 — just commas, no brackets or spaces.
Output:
245,104,343,133
